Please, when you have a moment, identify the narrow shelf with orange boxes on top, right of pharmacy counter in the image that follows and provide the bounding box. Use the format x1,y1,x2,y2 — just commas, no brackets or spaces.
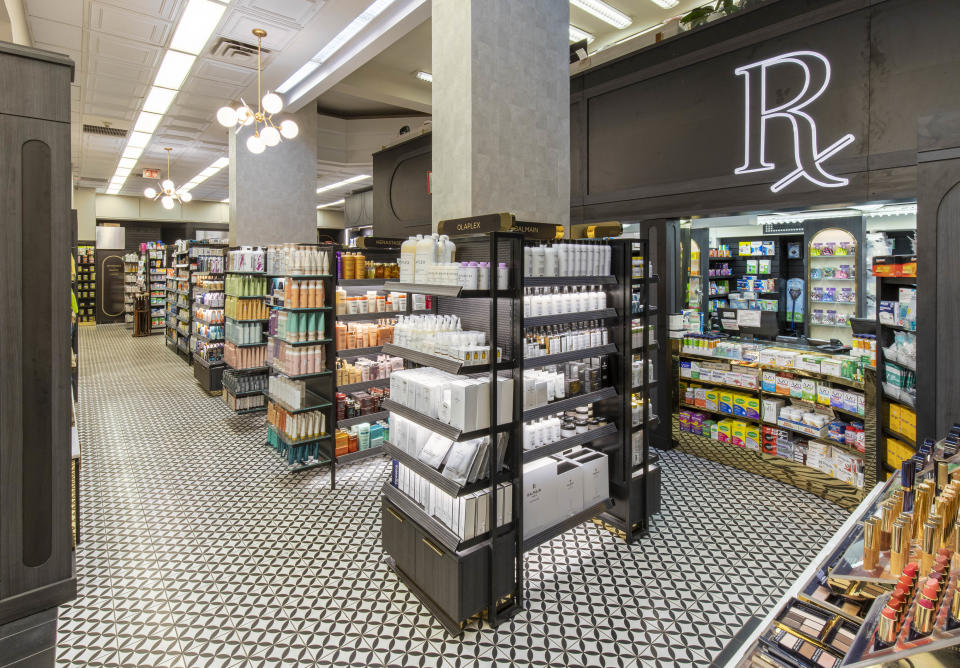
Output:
873,256,926,480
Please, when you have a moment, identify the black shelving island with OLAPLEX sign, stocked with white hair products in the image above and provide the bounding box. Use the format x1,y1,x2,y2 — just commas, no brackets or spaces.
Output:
382,231,659,635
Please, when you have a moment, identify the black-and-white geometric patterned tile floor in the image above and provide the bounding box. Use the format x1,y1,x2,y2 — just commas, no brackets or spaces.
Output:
58,325,843,666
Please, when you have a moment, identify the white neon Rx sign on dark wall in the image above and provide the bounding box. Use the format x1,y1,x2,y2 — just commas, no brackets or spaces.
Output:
734,51,854,193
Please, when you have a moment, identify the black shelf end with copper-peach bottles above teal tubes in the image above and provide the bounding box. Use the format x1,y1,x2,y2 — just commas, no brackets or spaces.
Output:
264,244,337,482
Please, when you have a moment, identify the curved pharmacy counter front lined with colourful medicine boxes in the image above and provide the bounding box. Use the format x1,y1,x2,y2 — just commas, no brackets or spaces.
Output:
674,334,884,508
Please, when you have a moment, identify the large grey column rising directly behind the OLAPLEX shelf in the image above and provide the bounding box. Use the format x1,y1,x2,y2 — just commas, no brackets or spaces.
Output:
431,0,570,229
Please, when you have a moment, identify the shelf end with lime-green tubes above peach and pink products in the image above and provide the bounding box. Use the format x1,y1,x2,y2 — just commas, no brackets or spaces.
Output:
222,247,269,415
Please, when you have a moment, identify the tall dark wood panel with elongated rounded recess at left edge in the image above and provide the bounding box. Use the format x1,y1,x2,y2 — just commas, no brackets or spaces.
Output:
0,41,76,622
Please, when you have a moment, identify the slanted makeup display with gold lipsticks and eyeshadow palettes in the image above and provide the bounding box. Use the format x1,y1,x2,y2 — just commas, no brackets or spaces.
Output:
726,426,960,668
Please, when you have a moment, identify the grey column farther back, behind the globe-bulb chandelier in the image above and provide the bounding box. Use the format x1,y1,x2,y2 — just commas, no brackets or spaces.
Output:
230,105,317,246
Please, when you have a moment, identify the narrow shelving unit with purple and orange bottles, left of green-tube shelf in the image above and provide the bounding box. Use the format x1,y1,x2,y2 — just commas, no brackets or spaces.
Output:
189,242,226,392
